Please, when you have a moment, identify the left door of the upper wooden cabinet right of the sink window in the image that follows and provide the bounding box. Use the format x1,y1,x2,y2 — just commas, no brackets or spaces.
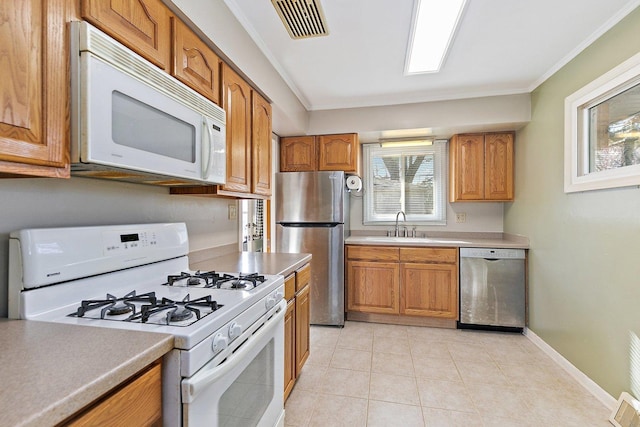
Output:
450,134,484,202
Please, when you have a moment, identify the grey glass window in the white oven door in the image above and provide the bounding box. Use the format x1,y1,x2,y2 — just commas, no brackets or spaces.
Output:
218,340,274,426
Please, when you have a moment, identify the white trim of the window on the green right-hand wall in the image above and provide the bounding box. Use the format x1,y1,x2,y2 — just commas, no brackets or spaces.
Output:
564,53,640,193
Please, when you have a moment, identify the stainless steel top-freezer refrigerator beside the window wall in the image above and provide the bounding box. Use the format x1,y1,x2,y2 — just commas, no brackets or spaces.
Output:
275,172,349,326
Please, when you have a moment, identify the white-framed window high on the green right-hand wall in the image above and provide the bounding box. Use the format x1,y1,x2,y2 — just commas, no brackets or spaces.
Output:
565,54,640,193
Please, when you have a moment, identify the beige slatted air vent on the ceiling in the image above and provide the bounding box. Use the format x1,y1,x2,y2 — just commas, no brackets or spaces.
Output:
271,0,329,39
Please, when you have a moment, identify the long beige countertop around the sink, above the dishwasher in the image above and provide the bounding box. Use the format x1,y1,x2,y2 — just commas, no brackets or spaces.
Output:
345,233,529,249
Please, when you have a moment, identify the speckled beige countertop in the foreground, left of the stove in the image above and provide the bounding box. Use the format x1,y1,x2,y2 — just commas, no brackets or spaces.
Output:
0,319,173,426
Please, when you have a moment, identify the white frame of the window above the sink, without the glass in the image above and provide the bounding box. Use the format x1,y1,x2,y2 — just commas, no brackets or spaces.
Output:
362,140,449,225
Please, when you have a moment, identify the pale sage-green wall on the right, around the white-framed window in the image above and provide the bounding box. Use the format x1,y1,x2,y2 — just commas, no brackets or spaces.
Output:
504,5,640,398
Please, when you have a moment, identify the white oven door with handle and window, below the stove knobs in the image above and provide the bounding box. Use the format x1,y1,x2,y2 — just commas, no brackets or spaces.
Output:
182,301,286,427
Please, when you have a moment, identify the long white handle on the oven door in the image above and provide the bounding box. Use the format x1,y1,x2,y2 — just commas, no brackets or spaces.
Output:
182,300,286,403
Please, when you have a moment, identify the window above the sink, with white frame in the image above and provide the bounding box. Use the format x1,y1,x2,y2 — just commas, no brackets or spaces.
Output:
363,141,447,225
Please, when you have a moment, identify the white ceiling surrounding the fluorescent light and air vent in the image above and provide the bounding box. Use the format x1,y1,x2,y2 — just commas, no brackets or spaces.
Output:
224,0,640,111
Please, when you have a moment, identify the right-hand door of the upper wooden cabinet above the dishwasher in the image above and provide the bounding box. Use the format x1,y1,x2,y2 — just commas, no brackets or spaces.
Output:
484,133,514,200
